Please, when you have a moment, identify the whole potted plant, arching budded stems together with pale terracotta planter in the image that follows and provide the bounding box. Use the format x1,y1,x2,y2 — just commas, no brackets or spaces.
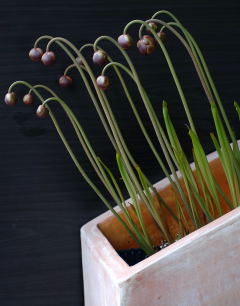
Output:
5,10,240,306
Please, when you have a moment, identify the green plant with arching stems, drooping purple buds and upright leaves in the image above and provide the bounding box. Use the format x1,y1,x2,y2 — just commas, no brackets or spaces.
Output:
5,10,240,254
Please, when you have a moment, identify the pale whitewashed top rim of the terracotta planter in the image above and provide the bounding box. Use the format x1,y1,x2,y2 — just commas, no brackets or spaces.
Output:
81,146,240,282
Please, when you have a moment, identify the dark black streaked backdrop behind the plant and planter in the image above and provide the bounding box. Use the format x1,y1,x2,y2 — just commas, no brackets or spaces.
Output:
0,0,240,306
